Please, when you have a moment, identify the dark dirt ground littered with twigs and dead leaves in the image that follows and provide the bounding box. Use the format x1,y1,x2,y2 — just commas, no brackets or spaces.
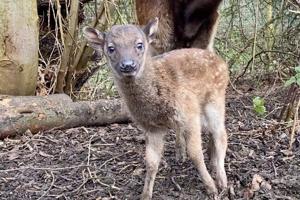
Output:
0,87,300,200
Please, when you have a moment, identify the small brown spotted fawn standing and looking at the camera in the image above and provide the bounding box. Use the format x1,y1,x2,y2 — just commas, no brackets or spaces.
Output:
83,18,229,200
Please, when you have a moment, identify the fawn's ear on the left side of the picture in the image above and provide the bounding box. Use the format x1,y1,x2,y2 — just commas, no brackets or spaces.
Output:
83,27,105,51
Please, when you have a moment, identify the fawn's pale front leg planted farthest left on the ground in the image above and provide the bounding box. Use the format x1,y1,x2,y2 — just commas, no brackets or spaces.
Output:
141,132,165,200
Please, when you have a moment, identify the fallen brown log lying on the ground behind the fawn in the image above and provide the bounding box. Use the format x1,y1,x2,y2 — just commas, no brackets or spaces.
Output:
0,94,130,139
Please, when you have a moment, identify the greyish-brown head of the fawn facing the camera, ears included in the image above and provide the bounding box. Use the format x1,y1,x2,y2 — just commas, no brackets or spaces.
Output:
83,18,158,78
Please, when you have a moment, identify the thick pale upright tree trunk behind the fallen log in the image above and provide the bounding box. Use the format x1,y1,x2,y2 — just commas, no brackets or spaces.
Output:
0,0,39,95
